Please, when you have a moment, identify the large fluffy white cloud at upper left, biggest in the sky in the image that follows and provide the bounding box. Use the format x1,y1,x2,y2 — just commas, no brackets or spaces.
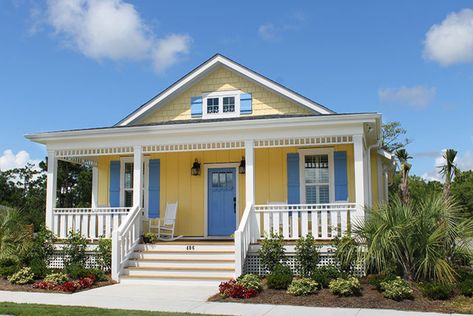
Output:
46,0,191,72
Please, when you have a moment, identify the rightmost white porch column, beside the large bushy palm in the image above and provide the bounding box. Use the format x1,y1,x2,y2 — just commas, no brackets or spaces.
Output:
352,135,366,222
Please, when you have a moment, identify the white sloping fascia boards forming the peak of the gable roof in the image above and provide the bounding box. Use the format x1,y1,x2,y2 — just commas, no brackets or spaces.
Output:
117,55,335,126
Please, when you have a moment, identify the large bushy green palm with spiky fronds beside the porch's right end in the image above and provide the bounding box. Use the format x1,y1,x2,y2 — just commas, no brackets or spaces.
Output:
354,194,473,283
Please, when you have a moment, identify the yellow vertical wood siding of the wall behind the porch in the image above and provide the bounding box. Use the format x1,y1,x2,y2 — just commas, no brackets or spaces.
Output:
98,145,355,236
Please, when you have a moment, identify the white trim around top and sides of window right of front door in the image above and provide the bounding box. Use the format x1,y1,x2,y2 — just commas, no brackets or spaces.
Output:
298,148,335,204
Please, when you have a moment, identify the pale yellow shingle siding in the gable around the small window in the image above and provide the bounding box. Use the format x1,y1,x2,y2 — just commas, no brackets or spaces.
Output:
140,66,311,124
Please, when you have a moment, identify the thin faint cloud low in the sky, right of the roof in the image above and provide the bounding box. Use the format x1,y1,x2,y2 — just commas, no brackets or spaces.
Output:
378,86,436,109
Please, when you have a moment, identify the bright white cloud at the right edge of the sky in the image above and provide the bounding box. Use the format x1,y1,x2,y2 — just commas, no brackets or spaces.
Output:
424,9,473,66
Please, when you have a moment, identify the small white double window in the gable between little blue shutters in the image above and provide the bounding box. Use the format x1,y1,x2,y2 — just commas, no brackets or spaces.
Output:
202,91,241,119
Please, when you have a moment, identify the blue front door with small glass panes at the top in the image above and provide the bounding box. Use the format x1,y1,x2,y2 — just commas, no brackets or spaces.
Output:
207,168,236,236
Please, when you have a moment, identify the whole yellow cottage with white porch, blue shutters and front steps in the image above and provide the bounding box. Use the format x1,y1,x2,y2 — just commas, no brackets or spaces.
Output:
27,54,392,283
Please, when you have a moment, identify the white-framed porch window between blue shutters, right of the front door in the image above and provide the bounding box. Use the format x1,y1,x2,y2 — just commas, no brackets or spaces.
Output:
299,149,335,204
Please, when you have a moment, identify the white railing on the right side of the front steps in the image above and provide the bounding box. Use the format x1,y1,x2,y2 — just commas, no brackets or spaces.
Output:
235,204,254,277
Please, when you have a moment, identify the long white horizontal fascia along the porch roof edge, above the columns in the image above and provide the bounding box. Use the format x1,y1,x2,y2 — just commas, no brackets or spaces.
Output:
26,114,376,149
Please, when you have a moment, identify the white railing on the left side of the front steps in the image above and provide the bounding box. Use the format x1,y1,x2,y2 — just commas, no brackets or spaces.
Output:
112,206,143,281
